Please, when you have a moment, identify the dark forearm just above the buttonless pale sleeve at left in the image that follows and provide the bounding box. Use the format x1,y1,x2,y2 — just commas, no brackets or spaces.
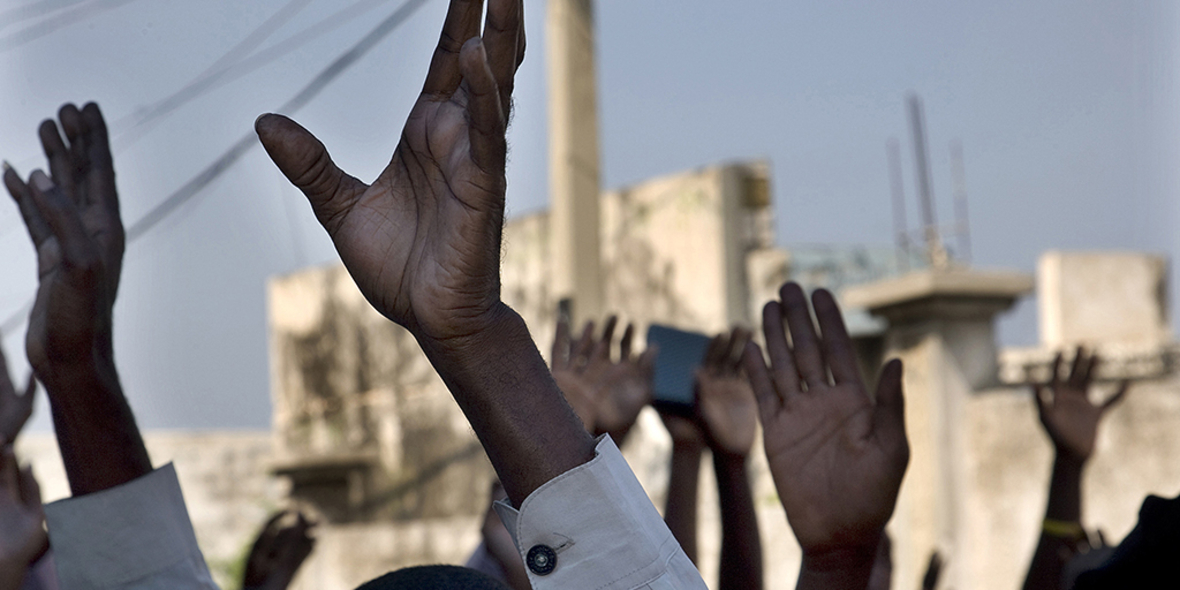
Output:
38,356,152,496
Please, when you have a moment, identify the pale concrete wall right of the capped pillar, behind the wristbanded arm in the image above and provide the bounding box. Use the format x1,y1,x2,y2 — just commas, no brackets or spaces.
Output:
962,375,1180,590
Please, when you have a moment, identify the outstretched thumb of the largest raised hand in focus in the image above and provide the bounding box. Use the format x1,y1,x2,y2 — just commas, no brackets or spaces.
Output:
254,113,368,232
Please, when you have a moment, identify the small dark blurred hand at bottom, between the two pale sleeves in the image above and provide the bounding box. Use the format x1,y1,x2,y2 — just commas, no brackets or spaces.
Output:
242,510,315,590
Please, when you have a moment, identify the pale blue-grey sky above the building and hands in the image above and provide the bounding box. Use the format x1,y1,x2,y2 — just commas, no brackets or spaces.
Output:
0,0,1180,428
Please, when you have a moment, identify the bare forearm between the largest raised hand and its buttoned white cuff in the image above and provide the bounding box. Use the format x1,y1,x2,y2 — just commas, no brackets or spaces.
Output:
419,303,595,507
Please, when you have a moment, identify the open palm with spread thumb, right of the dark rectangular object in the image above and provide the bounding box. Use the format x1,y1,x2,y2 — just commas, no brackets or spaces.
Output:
745,283,910,589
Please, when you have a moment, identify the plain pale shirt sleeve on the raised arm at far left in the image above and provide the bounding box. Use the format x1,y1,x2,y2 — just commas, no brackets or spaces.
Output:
45,464,217,590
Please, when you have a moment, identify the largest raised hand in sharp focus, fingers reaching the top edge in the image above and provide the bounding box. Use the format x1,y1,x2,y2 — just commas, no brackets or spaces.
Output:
255,0,525,352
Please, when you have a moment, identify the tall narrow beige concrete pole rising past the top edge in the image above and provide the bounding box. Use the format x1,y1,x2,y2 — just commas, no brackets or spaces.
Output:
545,0,603,321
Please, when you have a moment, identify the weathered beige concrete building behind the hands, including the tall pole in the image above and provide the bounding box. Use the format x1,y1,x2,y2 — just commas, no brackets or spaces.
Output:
9,0,1180,590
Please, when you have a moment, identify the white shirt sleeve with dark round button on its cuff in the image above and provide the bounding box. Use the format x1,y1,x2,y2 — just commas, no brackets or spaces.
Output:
496,435,706,590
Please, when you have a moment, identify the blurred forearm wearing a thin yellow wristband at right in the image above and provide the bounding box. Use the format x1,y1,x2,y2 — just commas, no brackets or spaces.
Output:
1023,453,1084,590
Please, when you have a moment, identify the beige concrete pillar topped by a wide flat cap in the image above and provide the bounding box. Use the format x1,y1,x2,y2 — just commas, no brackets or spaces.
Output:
844,270,1033,588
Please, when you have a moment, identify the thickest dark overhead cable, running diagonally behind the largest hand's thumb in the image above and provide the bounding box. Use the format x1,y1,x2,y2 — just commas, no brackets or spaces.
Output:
0,0,426,334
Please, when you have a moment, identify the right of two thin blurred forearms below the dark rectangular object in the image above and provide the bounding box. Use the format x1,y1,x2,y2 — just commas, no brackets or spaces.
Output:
713,450,762,590
